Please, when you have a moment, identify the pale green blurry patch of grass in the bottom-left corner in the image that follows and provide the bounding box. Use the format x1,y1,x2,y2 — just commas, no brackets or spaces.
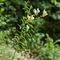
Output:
0,45,14,60
